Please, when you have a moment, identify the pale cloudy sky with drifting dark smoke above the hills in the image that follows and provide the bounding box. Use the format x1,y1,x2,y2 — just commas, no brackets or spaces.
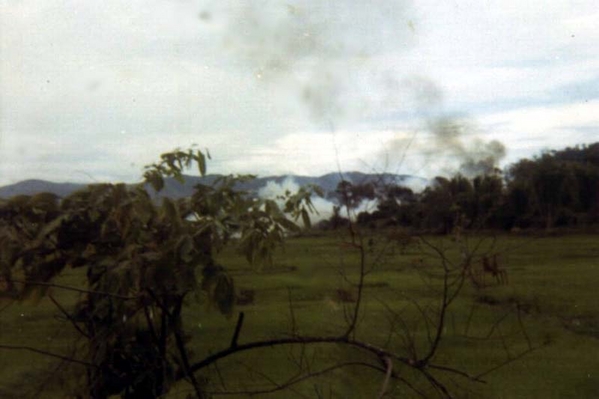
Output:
0,0,599,185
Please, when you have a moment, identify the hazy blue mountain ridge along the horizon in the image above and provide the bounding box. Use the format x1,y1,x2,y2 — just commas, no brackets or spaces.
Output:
0,172,427,202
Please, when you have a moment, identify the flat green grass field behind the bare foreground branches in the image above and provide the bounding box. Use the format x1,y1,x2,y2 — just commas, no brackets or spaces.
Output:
0,234,599,398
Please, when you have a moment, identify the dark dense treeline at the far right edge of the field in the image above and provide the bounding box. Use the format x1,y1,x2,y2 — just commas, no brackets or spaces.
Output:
321,143,599,233
